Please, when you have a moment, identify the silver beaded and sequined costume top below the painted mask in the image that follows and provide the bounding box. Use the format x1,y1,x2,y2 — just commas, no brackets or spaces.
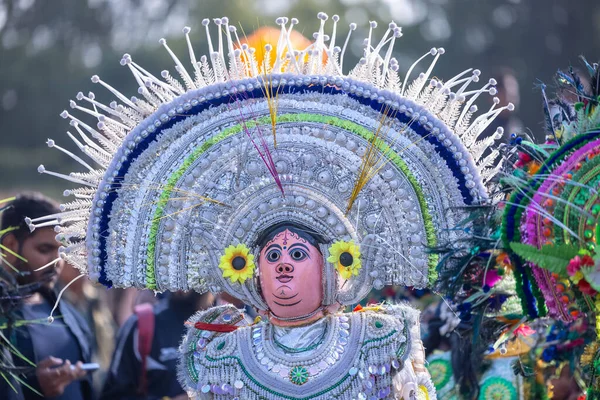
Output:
180,307,435,399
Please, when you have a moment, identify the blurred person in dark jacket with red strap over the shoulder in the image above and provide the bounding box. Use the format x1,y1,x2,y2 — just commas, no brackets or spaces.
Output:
101,292,214,400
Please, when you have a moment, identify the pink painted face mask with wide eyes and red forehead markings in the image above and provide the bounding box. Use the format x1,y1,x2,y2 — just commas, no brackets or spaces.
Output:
258,229,323,318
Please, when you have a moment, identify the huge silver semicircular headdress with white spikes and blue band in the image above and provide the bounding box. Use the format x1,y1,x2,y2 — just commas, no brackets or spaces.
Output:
31,13,512,307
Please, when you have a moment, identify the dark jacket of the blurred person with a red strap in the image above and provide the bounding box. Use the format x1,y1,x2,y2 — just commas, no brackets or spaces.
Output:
101,296,196,400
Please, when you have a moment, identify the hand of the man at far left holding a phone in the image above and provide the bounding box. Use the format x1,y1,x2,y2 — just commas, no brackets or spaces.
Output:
35,357,86,397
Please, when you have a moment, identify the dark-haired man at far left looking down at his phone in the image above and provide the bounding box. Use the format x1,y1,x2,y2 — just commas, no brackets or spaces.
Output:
0,193,93,400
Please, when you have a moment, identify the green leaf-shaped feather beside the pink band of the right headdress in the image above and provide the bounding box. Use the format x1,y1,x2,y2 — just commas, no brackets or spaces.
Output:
510,242,579,276
